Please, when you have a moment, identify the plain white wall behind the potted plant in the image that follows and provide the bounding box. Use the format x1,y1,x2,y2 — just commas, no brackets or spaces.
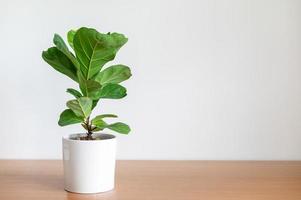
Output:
0,0,301,159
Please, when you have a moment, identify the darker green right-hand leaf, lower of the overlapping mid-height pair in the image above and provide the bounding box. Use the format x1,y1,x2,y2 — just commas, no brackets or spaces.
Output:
100,83,126,99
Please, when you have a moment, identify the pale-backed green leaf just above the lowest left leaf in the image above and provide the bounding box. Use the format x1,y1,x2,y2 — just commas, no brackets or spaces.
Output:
67,97,92,118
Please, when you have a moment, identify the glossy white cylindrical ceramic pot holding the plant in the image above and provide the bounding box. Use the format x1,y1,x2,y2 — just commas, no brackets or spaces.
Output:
63,134,116,193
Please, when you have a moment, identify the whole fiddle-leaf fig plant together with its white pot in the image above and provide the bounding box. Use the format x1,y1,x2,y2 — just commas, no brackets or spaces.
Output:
42,27,131,193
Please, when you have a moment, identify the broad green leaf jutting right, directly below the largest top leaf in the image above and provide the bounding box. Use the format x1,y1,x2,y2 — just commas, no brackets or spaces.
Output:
94,65,132,85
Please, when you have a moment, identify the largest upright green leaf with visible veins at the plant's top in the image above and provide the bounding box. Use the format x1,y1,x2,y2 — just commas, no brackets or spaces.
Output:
73,27,127,80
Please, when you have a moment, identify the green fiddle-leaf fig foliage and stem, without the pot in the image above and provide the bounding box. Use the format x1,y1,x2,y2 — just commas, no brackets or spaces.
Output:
42,27,131,140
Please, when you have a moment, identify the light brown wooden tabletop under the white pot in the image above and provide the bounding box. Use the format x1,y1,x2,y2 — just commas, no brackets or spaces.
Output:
0,160,301,200
